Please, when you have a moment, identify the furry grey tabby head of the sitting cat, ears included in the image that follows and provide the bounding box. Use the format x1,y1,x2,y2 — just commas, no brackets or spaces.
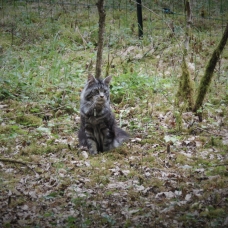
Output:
81,75,111,108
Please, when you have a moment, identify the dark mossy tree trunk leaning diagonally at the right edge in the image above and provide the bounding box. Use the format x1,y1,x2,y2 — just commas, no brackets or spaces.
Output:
193,23,228,112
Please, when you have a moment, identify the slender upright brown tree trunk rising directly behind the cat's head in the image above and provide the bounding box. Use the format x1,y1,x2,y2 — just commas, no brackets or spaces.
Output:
95,0,106,78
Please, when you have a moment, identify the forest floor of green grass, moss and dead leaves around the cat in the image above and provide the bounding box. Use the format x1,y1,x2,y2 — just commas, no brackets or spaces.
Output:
0,2,228,228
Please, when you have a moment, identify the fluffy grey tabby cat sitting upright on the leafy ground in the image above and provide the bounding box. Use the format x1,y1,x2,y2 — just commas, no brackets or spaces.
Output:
78,75,128,154
